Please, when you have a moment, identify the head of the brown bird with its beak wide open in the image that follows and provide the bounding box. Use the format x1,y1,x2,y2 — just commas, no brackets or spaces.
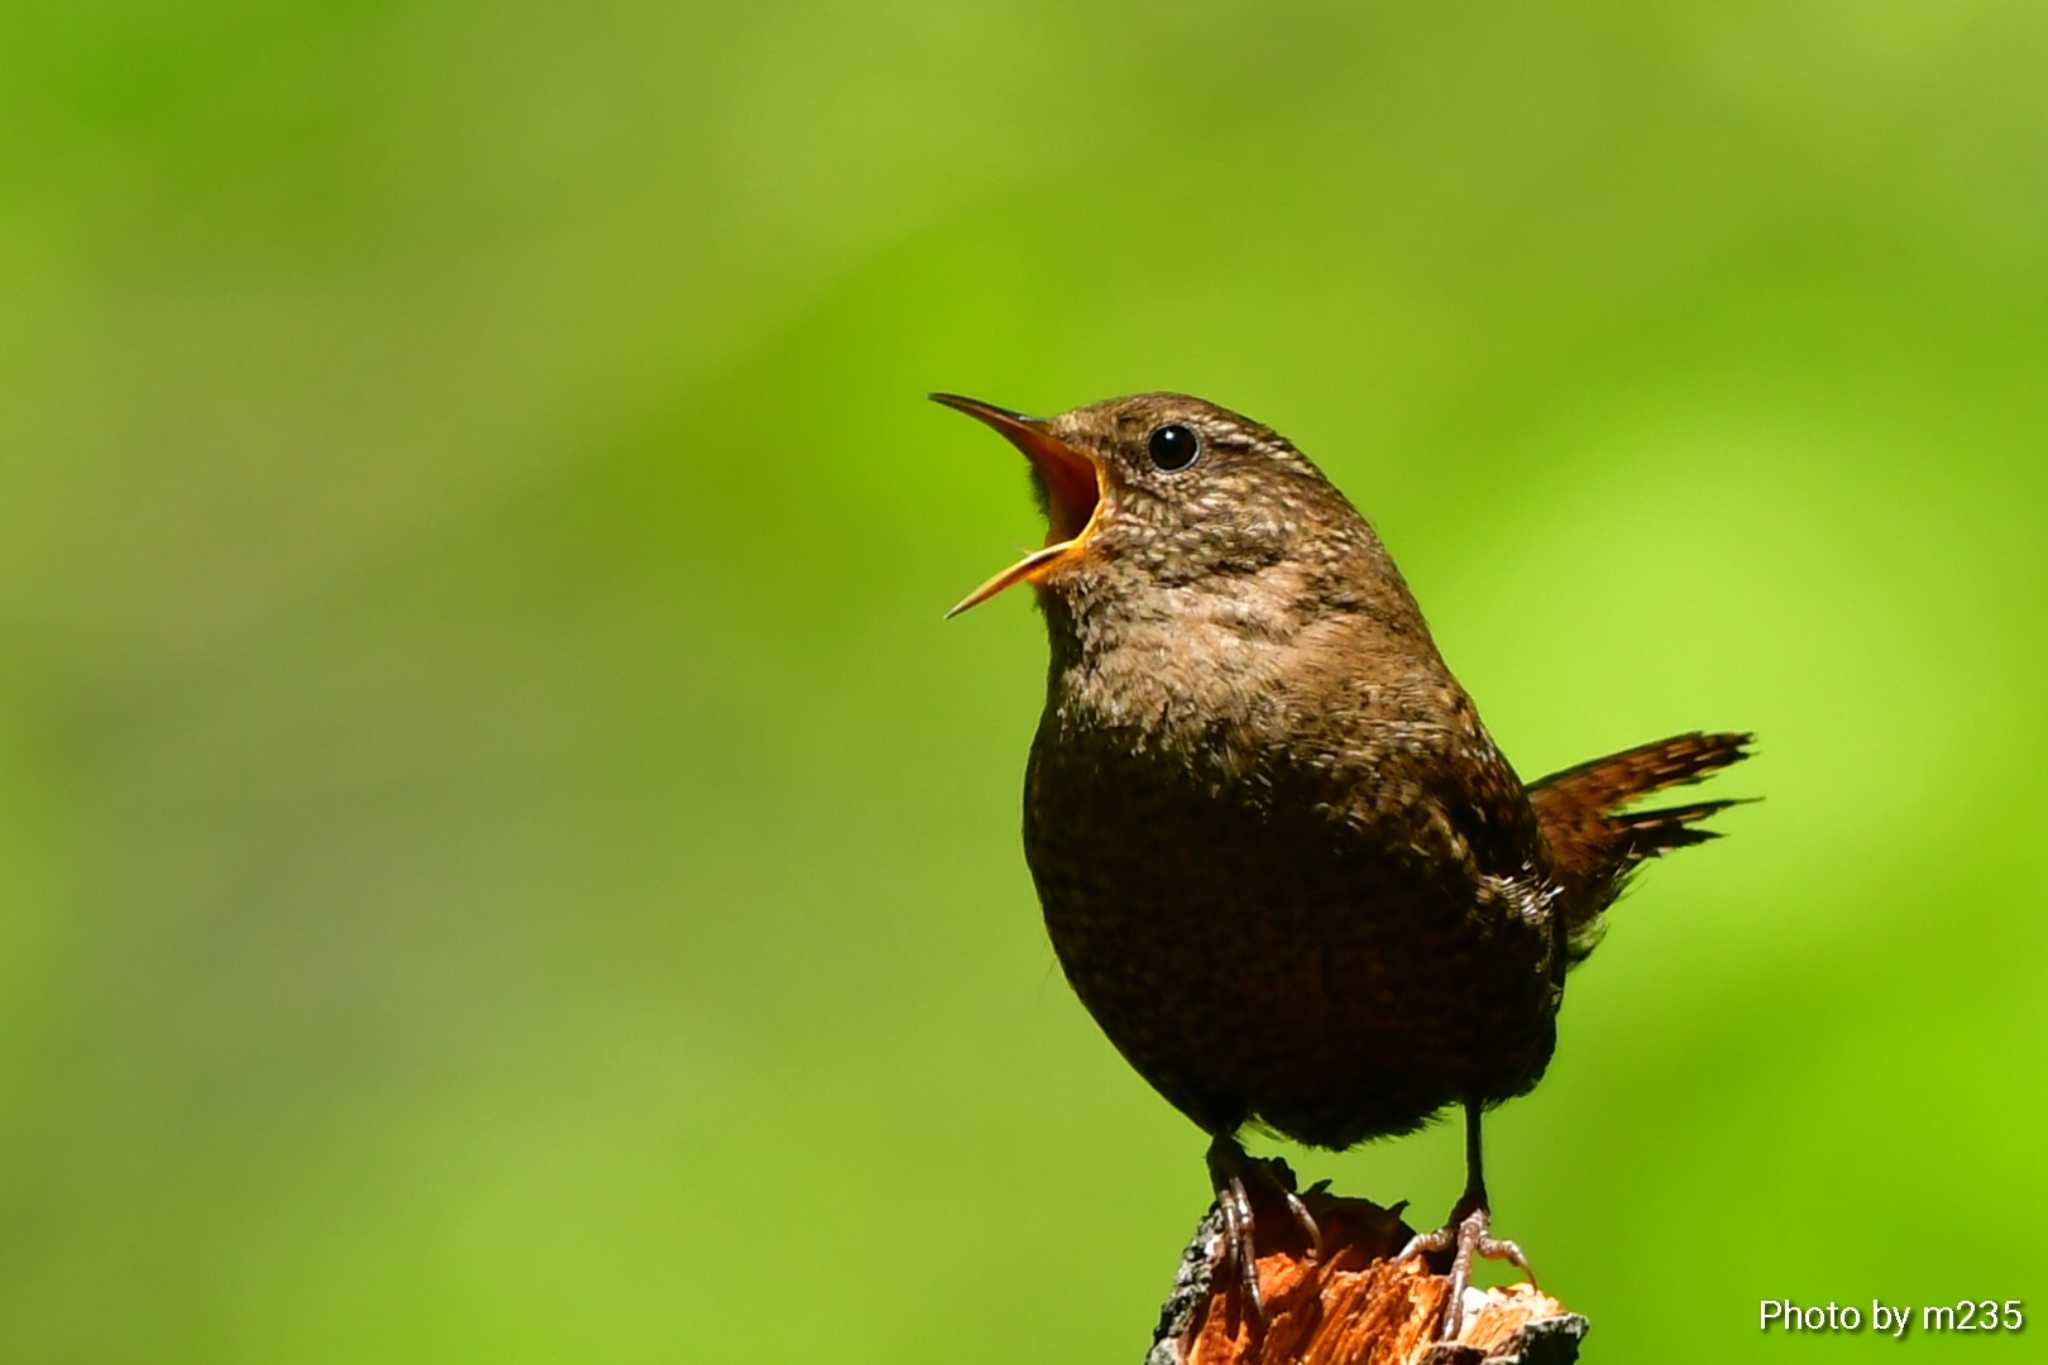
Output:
932,384,1378,616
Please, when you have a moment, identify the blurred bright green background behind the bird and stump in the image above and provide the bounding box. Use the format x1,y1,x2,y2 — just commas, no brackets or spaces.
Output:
0,0,2048,1365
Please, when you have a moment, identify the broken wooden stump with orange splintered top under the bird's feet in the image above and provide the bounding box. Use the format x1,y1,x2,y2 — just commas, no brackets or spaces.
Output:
1145,1169,1587,1365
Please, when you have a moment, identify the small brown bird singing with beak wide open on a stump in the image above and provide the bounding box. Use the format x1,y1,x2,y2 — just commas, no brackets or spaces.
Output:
930,393,1753,1338
